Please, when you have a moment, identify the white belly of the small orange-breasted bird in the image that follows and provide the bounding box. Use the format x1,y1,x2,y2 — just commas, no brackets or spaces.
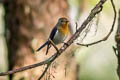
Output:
53,31,67,44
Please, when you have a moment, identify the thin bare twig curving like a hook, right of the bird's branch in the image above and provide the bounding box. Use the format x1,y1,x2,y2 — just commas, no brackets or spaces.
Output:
77,0,117,46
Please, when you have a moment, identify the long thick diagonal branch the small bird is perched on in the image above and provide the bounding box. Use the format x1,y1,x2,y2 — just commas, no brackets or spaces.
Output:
0,0,107,79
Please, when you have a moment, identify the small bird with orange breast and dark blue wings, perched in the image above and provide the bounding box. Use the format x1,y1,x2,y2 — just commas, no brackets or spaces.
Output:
37,17,69,55
